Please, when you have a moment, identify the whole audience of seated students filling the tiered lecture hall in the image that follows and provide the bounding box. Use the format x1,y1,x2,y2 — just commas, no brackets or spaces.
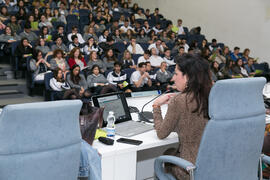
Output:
0,0,268,99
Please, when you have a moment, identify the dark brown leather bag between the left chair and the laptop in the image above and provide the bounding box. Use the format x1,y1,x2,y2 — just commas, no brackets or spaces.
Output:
79,102,104,145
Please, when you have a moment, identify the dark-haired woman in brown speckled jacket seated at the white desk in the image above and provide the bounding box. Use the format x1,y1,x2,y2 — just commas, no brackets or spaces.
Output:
153,54,212,180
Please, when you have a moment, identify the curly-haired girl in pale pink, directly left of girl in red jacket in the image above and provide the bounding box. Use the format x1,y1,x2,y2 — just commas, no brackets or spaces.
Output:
50,49,69,79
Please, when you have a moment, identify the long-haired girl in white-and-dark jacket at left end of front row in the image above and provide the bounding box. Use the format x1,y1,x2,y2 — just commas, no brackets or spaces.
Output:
50,68,78,100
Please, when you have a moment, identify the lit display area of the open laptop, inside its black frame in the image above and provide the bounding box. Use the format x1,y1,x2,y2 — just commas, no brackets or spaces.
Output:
96,94,130,122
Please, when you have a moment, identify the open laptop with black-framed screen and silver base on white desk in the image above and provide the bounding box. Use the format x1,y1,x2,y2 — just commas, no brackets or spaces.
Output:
92,92,154,137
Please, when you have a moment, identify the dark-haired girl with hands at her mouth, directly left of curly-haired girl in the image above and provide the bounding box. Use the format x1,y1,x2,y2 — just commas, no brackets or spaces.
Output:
30,51,51,81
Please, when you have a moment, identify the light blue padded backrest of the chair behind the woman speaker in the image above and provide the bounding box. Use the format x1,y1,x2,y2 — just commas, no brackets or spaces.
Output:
194,78,266,180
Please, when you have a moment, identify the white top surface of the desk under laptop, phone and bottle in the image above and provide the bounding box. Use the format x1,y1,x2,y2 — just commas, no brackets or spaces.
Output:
93,96,178,157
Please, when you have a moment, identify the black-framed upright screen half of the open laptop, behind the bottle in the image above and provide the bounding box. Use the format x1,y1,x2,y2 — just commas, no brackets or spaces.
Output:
92,92,131,125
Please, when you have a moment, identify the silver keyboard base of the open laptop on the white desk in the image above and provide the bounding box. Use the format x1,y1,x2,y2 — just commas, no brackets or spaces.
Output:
115,121,154,137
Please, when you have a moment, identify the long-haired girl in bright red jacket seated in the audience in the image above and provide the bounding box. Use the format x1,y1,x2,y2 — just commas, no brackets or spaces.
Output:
68,47,87,70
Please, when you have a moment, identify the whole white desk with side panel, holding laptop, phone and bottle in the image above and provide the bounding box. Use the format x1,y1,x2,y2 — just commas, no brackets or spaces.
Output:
93,96,178,180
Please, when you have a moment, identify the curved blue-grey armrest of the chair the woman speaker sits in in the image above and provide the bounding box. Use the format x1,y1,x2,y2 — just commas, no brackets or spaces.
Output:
155,155,196,179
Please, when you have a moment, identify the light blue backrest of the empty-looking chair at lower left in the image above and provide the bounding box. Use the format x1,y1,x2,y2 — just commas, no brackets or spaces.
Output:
0,100,82,180
